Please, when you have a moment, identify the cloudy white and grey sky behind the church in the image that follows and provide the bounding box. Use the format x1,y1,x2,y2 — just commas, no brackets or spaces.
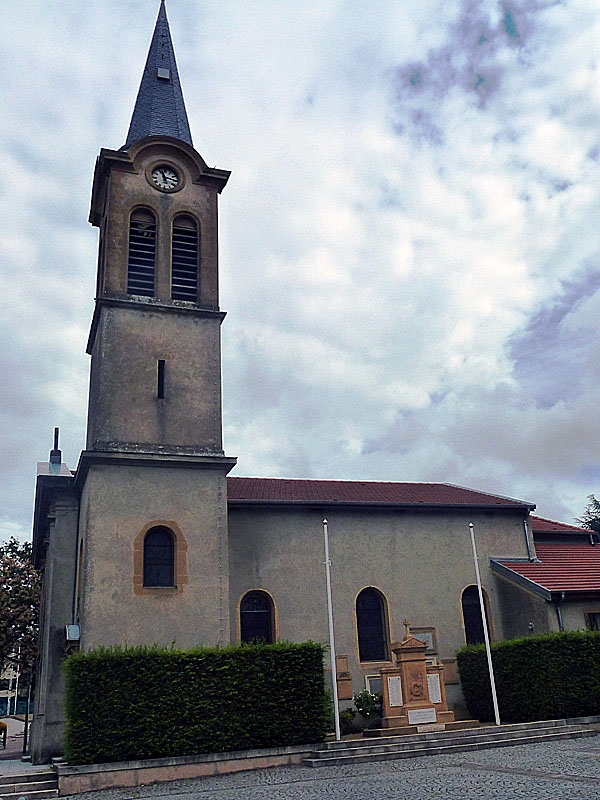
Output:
0,0,600,538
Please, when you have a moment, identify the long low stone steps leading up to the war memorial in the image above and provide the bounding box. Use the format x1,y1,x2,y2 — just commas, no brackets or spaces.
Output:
303,717,600,767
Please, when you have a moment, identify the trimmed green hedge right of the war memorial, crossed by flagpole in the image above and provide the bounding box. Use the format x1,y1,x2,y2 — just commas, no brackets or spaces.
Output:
456,631,600,722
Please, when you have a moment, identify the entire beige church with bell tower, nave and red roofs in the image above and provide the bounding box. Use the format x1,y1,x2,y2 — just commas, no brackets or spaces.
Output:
31,0,600,763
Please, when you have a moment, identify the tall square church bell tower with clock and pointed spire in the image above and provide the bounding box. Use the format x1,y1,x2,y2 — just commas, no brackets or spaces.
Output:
74,0,235,649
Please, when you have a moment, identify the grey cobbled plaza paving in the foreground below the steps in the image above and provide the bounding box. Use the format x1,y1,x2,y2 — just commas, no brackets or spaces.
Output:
72,736,600,800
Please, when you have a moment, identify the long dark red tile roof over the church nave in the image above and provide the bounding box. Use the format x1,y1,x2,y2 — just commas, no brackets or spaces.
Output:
227,478,535,510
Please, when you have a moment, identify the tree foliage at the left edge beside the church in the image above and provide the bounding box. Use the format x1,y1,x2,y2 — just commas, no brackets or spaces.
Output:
0,537,41,674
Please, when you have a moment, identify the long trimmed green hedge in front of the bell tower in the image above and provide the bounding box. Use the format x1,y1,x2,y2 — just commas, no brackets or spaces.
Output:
64,642,329,764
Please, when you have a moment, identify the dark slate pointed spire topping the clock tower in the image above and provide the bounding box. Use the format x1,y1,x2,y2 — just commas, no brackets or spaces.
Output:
122,0,192,150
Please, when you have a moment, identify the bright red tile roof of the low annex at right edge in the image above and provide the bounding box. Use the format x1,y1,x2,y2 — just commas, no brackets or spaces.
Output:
497,543,600,592
